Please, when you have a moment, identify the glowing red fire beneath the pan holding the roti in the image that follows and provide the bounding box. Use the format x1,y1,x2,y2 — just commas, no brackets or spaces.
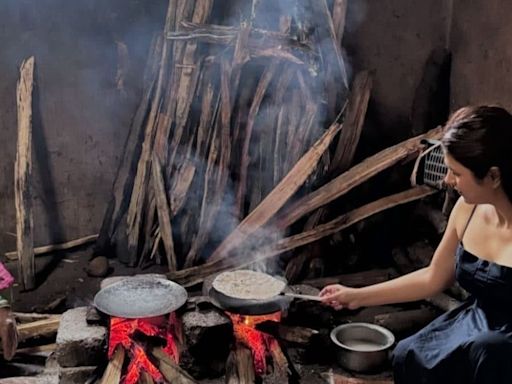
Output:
228,312,281,376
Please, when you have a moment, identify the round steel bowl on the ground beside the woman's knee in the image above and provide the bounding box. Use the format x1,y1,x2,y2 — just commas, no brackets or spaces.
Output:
331,323,395,373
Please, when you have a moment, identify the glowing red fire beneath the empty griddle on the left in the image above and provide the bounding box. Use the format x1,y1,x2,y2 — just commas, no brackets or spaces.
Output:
108,313,180,384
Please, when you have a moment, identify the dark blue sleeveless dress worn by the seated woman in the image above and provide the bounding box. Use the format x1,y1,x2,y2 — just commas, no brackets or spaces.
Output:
393,243,512,384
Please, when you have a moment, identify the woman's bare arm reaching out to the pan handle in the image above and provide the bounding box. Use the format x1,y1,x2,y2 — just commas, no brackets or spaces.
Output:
320,199,469,309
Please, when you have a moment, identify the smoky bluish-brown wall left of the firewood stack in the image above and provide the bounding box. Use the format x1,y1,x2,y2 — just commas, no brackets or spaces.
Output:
0,0,165,251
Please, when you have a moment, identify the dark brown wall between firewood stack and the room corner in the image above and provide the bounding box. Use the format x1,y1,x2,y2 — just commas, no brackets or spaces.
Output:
343,0,449,146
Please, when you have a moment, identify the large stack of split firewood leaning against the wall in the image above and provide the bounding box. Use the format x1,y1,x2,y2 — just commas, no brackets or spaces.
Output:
97,0,439,285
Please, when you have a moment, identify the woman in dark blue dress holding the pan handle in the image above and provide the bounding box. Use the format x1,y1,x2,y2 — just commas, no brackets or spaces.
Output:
320,106,512,384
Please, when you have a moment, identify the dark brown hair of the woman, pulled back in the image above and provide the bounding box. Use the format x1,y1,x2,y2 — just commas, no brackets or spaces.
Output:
442,106,512,202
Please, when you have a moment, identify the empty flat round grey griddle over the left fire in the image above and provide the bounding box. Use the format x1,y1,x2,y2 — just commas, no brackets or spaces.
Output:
94,277,188,319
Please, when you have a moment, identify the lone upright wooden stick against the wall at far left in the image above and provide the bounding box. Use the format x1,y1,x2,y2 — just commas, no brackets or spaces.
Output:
14,56,36,289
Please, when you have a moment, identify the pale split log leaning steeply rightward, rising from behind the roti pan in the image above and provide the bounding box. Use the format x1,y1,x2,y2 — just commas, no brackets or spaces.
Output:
206,120,340,262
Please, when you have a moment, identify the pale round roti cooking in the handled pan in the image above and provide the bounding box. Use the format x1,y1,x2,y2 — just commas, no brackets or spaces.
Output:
212,269,286,300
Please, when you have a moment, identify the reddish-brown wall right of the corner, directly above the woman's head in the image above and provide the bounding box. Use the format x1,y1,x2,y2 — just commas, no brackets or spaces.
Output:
450,0,512,110
